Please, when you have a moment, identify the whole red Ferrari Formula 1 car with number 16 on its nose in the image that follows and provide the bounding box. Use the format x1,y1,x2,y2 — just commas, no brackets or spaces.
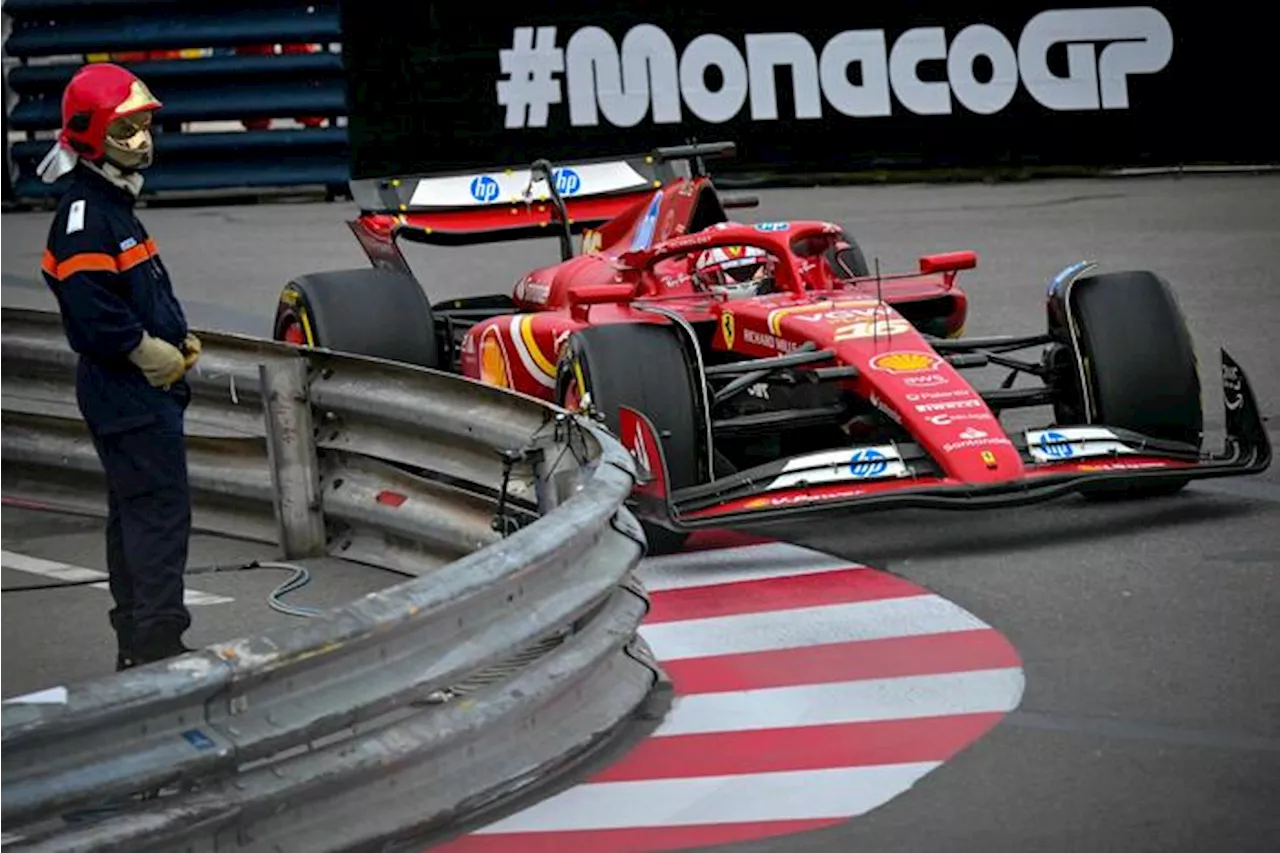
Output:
274,143,1271,552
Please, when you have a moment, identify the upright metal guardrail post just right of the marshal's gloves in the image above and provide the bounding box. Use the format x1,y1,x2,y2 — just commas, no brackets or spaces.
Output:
259,359,325,560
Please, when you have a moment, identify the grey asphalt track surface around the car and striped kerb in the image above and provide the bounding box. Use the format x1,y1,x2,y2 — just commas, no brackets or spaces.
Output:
0,175,1280,853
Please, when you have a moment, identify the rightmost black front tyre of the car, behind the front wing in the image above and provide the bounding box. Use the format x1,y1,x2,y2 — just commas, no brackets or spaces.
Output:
1055,270,1204,498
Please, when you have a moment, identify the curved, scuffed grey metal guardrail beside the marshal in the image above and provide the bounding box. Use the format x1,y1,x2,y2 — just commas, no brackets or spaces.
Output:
0,309,660,853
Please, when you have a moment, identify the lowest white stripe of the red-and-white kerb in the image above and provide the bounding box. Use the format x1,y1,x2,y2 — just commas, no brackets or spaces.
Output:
475,762,940,835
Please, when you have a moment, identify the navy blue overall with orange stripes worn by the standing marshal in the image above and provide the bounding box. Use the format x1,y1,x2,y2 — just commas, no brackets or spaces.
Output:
42,165,191,660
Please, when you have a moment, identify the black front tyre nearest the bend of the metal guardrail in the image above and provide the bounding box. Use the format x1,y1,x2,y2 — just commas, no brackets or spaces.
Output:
556,323,705,555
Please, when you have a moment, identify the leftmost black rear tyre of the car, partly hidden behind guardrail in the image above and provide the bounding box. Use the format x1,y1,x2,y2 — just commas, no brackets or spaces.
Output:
271,268,440,368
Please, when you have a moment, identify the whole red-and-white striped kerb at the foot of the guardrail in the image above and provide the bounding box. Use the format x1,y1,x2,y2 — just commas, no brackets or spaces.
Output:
431,537,1024,853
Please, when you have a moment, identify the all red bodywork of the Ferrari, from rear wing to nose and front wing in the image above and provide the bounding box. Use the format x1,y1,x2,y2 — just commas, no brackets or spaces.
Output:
340,158,1269,528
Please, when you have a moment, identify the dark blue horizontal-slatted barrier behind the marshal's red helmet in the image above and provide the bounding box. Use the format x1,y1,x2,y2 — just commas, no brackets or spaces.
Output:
0,0,349,200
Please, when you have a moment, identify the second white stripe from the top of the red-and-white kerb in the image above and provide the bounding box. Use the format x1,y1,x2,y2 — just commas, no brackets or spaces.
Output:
640,594,987,661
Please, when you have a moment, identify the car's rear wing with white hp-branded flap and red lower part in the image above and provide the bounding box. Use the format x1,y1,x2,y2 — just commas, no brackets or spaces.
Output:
351,142,736,251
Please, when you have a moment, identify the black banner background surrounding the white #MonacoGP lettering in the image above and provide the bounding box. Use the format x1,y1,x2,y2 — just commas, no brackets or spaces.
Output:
343,0,1280,178
